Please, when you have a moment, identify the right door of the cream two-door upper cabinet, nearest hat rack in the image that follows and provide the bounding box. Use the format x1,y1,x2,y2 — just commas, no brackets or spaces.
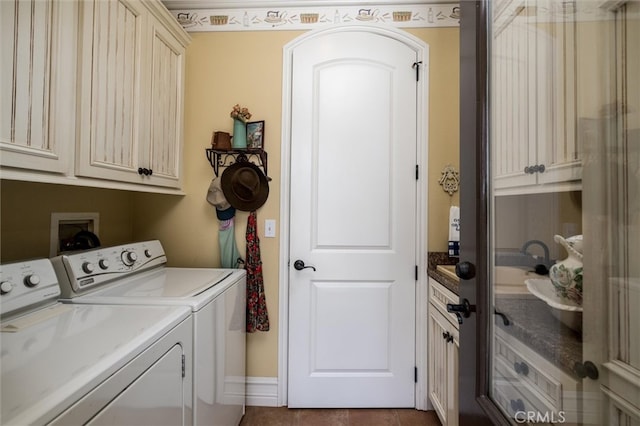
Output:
140,17,185,187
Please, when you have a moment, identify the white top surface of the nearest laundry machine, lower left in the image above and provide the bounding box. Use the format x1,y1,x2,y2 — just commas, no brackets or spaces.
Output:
0,304,191,425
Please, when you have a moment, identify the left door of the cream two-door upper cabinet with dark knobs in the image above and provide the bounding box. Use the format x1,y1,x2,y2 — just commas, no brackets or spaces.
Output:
76,0,146,182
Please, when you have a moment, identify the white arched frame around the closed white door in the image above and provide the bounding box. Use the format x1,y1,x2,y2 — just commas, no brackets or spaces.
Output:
277,24,430,410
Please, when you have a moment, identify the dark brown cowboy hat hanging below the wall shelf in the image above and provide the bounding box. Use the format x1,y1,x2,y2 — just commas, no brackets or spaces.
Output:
220,161,269,212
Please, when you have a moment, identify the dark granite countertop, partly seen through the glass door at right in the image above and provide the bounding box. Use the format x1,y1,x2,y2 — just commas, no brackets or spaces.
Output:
427,252,582,378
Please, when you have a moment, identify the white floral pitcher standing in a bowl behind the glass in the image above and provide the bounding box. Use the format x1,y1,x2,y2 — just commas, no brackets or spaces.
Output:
549,235,582,305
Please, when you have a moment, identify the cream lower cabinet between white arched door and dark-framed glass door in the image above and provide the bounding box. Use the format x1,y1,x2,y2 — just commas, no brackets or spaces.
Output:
428,278,460,426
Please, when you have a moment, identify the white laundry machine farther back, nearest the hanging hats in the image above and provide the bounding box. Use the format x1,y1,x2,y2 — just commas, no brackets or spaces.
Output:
52,240,246,426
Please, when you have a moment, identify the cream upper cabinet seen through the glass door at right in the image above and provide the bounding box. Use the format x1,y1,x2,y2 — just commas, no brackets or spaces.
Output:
492,0,582,195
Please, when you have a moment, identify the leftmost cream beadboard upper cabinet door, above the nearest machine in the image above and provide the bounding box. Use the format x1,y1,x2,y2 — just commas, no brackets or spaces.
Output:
0,0,77,173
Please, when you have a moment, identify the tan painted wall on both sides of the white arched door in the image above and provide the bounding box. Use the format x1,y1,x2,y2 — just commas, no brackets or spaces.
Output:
134,25,459,377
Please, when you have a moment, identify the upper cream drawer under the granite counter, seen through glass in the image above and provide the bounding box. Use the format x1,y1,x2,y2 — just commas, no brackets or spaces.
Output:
495,336,562,410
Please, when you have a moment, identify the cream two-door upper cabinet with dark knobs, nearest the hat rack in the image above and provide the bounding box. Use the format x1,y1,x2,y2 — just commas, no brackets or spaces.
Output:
76,0,189,188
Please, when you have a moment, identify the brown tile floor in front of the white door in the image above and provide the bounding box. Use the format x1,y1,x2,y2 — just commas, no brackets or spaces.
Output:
240,407,440,426
